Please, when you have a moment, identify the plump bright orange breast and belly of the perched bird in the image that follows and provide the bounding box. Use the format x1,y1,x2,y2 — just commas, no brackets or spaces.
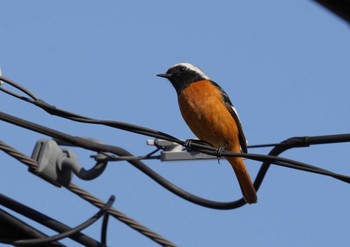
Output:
178,80,238,148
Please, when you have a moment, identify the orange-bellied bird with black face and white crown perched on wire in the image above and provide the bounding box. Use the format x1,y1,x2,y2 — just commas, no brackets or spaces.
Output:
157,63,258,204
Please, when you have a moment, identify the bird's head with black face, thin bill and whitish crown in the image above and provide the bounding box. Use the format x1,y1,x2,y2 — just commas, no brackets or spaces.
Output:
157,63,209,95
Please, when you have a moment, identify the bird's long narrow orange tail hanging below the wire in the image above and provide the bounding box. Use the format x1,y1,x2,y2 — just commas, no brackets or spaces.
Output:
227,157,258,204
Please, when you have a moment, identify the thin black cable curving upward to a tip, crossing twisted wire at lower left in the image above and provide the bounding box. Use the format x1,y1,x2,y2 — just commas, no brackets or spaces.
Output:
13,196,115,246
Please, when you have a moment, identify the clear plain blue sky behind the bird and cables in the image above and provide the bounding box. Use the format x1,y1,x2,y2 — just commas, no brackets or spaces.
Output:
0,0,350,246
